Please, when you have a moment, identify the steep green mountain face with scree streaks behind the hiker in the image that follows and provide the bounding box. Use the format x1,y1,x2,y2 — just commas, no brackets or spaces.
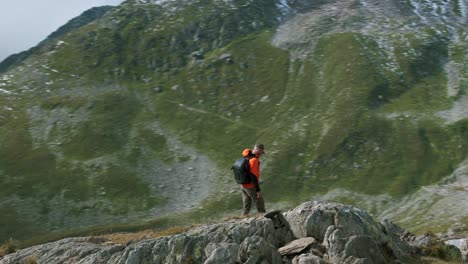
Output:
0,0,468,243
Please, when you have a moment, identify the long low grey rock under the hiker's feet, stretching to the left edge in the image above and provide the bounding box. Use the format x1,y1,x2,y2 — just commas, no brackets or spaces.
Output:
0,211,293,264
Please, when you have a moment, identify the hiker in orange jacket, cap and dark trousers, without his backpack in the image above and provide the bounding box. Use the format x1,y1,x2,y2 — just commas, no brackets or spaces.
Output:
241,144,265,216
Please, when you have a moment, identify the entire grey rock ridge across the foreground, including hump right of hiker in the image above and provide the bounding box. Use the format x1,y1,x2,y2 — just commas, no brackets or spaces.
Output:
0,202,460,264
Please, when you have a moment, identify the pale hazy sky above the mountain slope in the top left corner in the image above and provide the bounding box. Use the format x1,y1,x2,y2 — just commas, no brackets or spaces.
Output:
0,0,123,62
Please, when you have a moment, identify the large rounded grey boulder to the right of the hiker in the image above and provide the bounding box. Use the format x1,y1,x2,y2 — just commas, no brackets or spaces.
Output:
285,202,411,263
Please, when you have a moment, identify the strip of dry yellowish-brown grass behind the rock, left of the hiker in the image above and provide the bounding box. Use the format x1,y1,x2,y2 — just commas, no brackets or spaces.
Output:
102,226,193,245
